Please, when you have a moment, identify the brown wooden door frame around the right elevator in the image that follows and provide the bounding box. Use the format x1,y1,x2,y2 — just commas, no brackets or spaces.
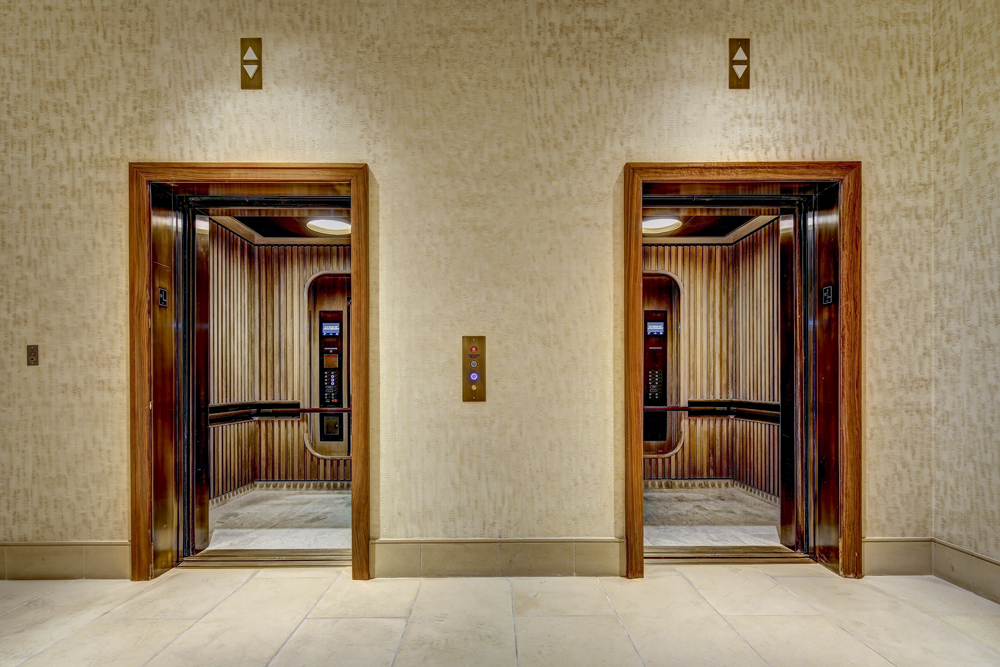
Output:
624,162,863,579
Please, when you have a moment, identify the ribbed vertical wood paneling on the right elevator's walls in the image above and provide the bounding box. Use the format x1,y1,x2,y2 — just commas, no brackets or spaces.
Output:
643,222,780,495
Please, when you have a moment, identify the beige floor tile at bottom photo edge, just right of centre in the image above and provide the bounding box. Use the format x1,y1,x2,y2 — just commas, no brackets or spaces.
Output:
516,616,642,667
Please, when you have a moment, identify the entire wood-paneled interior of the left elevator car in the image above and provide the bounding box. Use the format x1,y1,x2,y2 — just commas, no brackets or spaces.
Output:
203,207,351,556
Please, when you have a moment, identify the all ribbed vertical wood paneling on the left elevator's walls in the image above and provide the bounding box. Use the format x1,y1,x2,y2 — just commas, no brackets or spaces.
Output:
209,223,351,498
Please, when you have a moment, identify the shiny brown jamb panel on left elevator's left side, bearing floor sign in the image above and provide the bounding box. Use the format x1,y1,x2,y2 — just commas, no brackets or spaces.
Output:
150,188,180,577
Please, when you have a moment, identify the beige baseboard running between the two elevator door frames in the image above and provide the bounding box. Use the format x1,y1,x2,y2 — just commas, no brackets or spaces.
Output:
371,538,624,578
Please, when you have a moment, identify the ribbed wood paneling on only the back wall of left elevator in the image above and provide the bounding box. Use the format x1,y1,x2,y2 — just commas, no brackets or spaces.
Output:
257,246,351,480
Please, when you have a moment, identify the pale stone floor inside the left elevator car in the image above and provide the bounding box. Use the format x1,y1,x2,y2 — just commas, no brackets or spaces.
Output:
206,489,351,551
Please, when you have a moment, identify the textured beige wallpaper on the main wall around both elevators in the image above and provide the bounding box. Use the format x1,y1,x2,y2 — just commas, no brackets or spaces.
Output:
0,0,944,544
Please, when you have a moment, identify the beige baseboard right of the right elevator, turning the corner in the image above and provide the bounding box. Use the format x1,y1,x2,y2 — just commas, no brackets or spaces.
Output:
864,537,1000,602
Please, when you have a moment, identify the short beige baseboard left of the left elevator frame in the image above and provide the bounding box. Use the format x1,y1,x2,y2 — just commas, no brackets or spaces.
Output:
0,541,132,579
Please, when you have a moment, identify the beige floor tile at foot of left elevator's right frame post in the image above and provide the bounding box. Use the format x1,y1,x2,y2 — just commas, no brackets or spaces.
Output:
309,577,420,618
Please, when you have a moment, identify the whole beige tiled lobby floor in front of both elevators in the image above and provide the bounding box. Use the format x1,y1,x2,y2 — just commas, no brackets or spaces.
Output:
0,564,1000,667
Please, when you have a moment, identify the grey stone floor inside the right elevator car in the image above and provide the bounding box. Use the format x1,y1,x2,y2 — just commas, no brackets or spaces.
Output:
643,488,781,547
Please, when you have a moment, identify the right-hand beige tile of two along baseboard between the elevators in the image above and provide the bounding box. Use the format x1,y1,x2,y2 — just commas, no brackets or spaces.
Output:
511,577,615,616
